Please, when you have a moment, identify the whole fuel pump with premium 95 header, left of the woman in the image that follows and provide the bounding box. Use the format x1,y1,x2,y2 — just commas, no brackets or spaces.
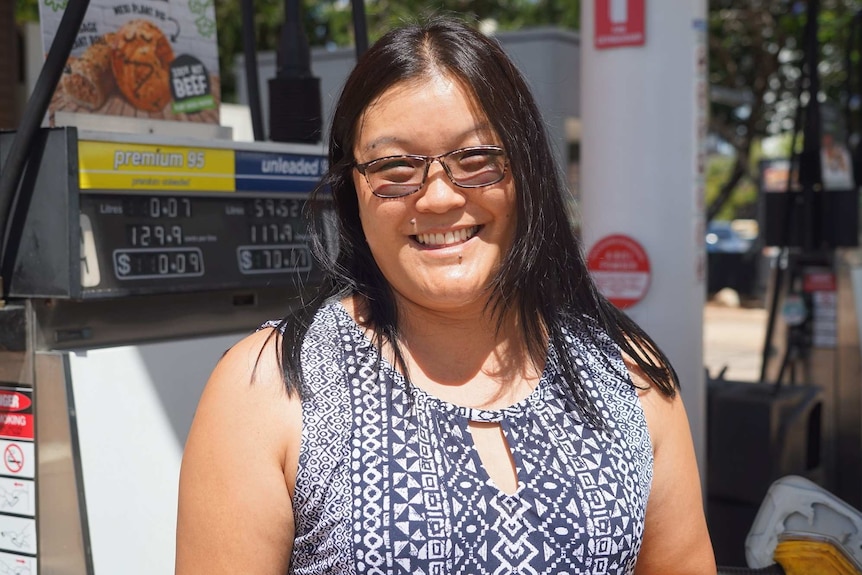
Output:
0,0,344,575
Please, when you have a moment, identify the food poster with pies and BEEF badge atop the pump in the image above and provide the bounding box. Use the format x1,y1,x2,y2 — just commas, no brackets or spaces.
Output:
39,0,221,125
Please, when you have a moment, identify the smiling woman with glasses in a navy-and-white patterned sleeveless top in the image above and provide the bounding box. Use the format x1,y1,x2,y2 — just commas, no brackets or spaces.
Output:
177,13,715,575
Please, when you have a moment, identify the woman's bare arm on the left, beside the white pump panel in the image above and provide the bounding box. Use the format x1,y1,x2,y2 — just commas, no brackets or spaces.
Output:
176,330,301,575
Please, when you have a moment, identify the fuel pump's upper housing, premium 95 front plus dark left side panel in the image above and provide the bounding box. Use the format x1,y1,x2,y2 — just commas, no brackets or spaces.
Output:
0,128,337,299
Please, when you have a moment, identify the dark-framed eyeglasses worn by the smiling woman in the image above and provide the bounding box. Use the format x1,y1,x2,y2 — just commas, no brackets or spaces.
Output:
356,146,508,198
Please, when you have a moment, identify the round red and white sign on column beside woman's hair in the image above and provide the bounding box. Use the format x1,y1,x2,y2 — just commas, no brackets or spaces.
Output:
587,234,650,309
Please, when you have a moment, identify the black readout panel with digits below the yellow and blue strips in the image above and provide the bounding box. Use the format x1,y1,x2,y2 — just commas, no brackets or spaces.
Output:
81,193,328,295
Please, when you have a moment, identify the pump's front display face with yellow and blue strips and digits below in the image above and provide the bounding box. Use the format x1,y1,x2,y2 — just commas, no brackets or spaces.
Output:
73,135,334,297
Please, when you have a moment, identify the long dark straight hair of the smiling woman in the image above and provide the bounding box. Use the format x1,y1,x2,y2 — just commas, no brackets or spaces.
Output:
274,17,678,425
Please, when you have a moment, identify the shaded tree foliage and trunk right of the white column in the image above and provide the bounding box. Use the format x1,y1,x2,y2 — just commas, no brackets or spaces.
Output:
706,0,857,219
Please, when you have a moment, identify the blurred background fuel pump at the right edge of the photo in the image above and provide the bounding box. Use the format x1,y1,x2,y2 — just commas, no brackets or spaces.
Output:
760,0,862,507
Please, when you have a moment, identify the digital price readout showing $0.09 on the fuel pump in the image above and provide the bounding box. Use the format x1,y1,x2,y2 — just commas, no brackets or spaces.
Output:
114,248,204,280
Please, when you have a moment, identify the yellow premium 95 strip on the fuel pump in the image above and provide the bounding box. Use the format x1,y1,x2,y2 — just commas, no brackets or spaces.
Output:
78,141,236,192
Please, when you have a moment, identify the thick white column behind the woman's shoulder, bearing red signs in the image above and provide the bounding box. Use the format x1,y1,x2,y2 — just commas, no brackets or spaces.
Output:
580,0,707,472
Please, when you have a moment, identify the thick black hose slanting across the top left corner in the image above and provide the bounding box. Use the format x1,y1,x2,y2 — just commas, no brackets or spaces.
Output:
0,0,90,297
